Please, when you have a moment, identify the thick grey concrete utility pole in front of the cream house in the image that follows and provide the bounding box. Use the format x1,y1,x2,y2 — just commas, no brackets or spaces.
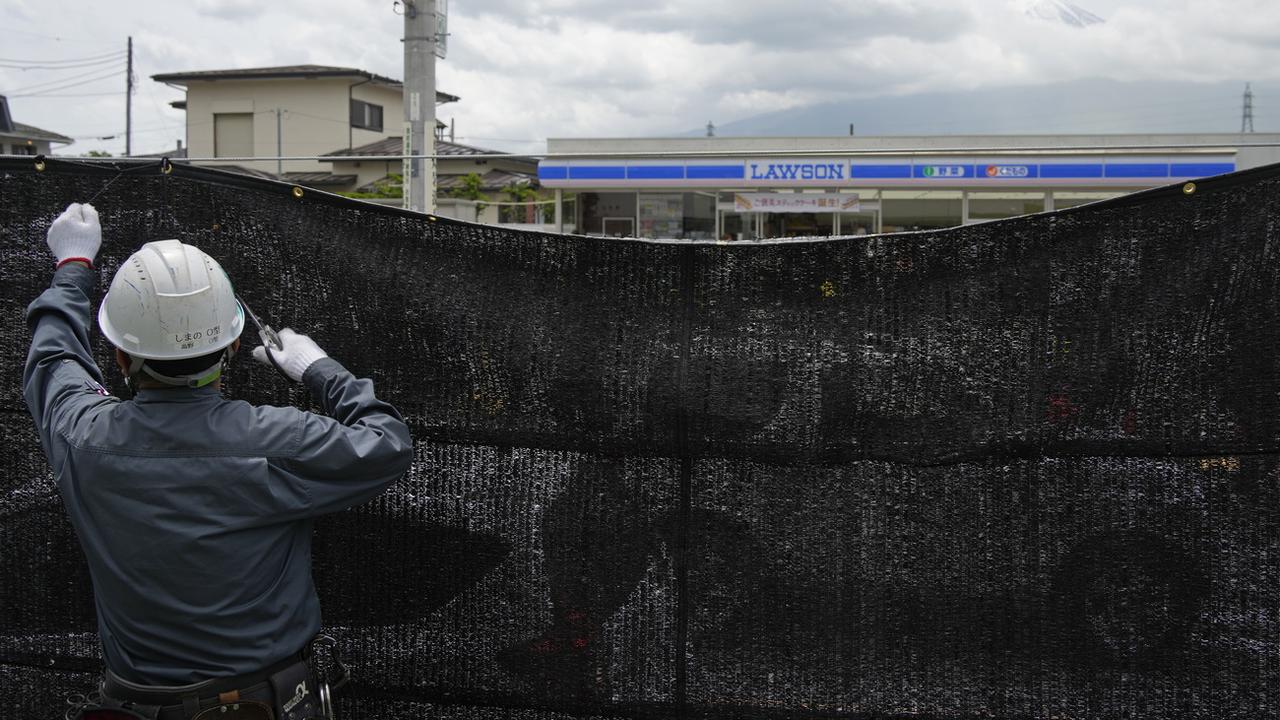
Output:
402,0,436,213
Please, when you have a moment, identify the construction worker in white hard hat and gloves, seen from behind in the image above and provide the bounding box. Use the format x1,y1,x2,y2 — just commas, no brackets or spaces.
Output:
23,204,412,720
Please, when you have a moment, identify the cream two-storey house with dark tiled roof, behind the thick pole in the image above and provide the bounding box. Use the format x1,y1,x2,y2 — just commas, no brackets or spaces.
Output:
151,65,550,223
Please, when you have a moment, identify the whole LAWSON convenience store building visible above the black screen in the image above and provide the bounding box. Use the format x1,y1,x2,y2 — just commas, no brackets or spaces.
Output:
538,135,1280,241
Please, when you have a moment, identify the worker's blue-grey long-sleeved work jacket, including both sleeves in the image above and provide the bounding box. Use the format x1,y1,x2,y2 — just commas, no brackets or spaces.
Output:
23,264,412,684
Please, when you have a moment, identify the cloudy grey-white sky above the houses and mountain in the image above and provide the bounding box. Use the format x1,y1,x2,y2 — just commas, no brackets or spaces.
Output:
0,0,1280,154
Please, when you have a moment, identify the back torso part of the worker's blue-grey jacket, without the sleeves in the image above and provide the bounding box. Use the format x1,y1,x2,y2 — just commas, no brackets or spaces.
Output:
58,388,319,684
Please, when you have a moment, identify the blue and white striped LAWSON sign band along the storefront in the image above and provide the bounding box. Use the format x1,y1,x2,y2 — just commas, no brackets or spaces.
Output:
538,155,1235,187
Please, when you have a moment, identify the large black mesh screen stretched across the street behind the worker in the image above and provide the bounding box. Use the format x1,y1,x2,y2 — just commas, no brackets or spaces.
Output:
0,159,1280,720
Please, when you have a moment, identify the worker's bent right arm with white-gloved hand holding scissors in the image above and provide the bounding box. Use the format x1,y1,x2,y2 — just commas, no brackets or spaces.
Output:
253,328,413,515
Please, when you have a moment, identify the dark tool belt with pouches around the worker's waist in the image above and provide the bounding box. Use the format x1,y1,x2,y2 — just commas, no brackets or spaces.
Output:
65,635,349,720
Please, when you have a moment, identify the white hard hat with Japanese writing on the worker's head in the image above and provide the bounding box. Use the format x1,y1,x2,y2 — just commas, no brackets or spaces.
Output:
97,240,244,360
